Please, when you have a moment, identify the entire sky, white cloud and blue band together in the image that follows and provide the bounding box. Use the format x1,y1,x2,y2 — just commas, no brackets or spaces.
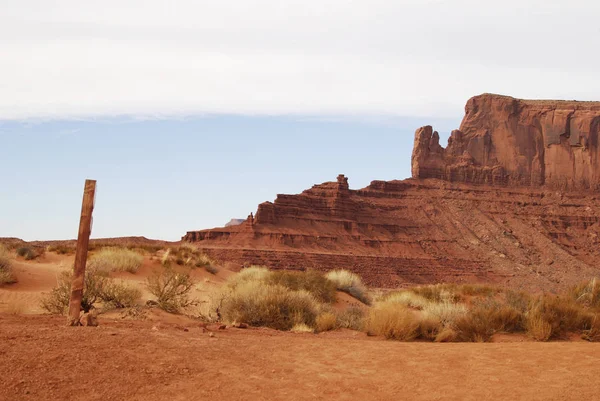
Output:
0,0,600,240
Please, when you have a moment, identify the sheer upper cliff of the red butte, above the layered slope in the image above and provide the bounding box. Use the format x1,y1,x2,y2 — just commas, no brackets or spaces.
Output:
412,94,600,190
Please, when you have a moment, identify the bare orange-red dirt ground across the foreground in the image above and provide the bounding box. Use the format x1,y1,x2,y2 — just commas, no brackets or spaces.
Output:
0,314,600,401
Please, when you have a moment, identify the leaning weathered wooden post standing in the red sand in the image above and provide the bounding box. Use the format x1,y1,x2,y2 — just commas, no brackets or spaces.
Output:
68,180,96,326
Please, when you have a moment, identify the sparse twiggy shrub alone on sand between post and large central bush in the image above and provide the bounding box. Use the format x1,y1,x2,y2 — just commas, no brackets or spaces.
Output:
146,268,194,313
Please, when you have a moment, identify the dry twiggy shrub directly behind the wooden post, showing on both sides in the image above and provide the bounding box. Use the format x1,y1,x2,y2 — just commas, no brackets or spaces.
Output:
41,269,107,315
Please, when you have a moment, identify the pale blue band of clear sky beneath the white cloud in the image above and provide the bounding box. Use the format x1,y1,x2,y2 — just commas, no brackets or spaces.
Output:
0,116,462,241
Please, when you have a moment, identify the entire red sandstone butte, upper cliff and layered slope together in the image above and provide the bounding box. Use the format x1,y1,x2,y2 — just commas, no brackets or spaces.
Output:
183,95,600,290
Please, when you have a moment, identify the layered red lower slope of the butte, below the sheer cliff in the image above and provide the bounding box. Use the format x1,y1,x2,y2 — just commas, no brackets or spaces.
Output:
183,176,600,290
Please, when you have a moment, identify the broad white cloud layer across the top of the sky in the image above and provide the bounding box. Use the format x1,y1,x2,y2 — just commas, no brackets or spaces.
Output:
0,0,600,119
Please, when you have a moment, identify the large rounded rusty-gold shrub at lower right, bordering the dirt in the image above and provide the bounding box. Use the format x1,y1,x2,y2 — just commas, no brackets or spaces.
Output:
526,295,593,341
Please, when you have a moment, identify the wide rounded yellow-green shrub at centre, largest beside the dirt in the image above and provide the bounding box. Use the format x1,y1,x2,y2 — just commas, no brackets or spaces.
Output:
220,280,319,330
